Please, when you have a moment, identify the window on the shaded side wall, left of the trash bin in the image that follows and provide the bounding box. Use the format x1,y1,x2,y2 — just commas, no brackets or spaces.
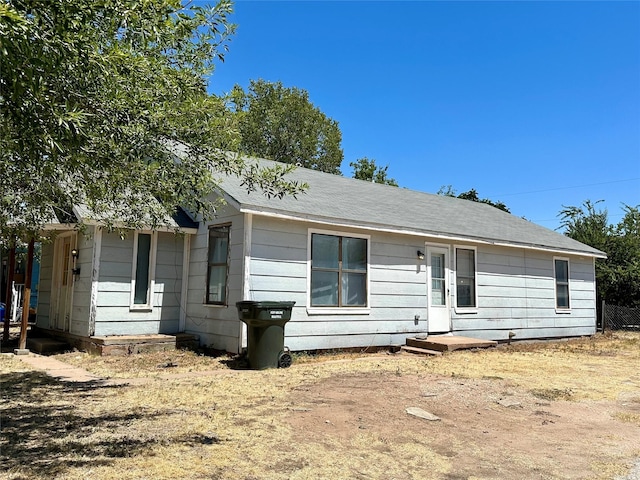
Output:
205,225,230,305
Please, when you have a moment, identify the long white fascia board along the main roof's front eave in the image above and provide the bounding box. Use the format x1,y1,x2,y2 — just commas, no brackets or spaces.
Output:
239,207,607,258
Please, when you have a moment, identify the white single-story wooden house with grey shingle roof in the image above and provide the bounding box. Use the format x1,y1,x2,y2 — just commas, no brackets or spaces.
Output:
37,160,604,352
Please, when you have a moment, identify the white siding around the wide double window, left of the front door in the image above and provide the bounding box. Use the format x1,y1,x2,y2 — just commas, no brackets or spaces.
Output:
240,216,426,350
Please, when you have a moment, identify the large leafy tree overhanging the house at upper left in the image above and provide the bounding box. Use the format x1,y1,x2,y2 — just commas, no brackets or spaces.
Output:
0,0,300,240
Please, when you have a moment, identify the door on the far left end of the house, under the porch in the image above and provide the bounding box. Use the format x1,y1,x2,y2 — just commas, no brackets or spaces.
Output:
52,236,73,332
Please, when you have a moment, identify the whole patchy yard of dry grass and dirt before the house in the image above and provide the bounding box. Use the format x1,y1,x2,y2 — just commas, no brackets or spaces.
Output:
0,333,640,480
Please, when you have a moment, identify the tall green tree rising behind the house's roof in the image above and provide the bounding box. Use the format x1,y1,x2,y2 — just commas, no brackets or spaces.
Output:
229,80,343,174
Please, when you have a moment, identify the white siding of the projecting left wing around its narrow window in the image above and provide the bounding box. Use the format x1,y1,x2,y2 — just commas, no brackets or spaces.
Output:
94,232,184,336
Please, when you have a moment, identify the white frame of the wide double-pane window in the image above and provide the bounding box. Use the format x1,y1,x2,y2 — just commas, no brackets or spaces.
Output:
307,228,371,315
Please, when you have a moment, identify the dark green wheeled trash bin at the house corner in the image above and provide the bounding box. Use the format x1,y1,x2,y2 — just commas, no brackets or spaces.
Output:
236,301,296,370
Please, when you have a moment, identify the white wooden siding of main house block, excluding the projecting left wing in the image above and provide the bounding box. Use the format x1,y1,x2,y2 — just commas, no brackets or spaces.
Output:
186,210,595,352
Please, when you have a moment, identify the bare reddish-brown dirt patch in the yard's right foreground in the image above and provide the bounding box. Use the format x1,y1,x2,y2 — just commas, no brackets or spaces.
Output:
289,375,640,479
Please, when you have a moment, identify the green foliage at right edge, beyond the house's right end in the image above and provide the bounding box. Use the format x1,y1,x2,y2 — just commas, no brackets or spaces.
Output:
560,200,640,307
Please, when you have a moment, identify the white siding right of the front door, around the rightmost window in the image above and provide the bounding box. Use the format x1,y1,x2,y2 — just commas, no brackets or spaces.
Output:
452,246,596,340
